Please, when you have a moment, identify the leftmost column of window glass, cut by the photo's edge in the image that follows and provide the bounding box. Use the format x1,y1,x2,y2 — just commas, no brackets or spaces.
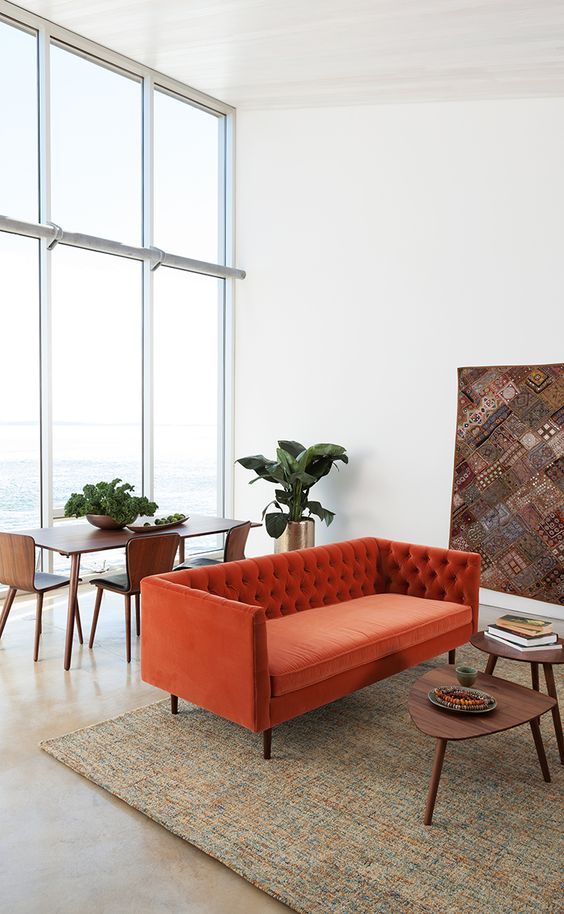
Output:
0,20,41,530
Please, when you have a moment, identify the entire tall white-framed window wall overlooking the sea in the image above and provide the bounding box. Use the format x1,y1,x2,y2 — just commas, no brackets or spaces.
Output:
0,8,238,568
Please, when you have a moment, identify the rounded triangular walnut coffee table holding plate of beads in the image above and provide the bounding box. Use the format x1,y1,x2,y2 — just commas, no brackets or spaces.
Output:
408,666,556,825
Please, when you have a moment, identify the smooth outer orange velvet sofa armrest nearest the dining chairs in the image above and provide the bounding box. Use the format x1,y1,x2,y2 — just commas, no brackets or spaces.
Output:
141,576,270,732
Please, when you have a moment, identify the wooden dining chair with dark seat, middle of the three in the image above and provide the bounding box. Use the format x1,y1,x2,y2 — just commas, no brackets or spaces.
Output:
88,533,180,663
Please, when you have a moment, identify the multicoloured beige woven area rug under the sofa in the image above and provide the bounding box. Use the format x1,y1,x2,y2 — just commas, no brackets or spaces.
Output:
42,648,564,914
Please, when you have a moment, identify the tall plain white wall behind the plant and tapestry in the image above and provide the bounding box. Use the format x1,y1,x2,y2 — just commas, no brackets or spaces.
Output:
234,99,564,610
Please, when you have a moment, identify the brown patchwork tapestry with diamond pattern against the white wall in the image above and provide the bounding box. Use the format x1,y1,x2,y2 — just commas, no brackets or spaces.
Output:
450,364,564,604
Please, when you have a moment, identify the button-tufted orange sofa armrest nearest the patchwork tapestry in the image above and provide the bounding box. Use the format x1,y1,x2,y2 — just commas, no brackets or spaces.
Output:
378,539,480,631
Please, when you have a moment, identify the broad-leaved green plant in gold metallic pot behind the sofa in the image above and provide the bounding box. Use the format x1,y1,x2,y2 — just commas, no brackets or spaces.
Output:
236,441,349,552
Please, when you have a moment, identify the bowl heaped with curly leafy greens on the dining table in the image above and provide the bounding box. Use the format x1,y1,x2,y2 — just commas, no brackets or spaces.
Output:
65,479,158,530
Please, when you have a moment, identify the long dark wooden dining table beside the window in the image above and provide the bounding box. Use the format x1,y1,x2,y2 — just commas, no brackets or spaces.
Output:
18,514,260,670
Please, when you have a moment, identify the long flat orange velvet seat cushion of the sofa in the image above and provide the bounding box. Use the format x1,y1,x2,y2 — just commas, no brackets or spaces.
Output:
266,593,472,696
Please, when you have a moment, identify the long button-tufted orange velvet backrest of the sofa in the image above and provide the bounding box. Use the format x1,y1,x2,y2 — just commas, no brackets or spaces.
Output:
170,537,383,619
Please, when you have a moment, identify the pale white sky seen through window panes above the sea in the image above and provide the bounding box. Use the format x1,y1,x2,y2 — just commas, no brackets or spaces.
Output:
0,22,221,430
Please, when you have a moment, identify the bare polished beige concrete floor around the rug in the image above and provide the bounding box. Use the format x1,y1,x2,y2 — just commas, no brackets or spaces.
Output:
0,587,564,914
